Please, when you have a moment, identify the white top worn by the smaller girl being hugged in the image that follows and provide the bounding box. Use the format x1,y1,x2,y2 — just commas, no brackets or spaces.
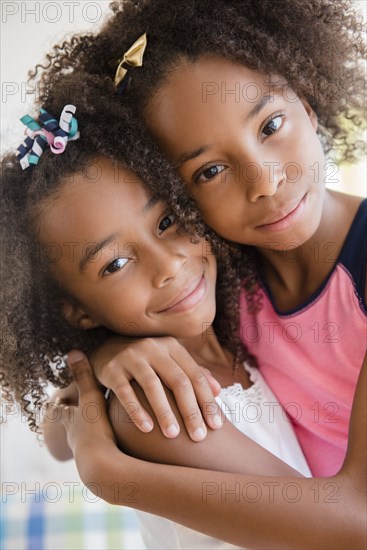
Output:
137,364,311,550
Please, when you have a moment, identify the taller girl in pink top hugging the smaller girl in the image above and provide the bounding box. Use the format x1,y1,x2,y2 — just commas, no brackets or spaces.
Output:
18,0,367,548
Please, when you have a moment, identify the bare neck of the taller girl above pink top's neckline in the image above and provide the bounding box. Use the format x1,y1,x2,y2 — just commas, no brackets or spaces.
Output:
259,190,361,311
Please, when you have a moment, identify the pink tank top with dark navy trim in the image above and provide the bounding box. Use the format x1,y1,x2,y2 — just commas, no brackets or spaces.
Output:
240,199,367,476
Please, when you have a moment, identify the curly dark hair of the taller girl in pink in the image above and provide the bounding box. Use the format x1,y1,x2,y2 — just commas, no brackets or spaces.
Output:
33,0,367,162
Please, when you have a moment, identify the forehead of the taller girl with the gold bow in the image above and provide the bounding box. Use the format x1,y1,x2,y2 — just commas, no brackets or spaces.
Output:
144,56,292,161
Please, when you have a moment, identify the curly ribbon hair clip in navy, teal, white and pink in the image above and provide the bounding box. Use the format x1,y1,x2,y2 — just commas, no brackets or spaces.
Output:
16,105,80,170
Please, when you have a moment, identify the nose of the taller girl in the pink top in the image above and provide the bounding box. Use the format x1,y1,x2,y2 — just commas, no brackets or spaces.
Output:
242,160,285,206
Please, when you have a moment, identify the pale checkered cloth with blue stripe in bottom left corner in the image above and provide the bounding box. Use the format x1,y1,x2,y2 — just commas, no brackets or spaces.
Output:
0,490,144,550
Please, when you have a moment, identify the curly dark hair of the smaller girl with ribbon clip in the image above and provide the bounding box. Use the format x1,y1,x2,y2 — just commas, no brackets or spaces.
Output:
0,71,254,431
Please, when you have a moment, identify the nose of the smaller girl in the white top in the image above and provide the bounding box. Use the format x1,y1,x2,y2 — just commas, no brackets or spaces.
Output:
151,242,187,288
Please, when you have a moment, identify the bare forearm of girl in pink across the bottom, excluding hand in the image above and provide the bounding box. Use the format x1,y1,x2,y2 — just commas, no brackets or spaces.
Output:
97,449,366,550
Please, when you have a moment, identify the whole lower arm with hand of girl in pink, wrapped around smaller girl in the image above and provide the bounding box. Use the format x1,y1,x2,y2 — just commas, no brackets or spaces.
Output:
61,358,367,550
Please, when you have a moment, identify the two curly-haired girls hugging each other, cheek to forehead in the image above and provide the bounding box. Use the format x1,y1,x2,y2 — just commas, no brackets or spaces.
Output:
1,0,367,549
